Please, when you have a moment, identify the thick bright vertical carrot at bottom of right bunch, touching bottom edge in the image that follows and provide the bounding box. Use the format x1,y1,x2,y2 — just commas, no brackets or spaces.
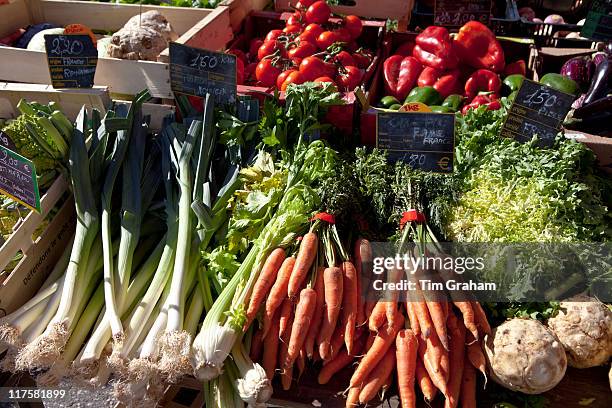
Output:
395,329,419,408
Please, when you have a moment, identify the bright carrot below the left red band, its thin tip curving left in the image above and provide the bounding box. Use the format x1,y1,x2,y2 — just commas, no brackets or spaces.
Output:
317,267,342,360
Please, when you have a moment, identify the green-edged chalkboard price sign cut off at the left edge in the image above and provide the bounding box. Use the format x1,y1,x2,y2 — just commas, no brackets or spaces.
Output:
0,146,40,212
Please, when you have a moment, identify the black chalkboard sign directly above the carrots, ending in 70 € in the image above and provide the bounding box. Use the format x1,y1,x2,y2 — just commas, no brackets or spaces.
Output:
376,112,455,173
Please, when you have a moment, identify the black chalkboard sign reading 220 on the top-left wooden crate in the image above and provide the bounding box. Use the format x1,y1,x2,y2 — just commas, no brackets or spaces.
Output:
45,34,98,88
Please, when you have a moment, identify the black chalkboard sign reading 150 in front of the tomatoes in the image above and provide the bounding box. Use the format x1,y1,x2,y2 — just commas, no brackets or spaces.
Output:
170,43,237,106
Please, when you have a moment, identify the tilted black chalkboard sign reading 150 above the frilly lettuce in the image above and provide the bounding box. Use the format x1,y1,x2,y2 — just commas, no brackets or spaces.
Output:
501,80,576,147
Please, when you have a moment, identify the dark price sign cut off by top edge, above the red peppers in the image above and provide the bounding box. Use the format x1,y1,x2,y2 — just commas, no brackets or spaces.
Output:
434,0,493,27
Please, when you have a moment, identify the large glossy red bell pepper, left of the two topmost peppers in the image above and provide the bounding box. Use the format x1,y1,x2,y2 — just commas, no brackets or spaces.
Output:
412,26,459,71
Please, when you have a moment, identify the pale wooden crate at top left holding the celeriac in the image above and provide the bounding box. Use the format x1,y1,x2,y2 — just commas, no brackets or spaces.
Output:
0,0,232,98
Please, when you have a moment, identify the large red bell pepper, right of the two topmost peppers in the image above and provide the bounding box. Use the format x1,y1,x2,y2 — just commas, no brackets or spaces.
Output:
454,21,506,72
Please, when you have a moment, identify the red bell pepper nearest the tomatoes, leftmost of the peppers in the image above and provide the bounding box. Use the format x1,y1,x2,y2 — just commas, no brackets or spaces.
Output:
383,55,423,101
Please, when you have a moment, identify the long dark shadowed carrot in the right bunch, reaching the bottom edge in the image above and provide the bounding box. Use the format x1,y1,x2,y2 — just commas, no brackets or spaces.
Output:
444,313,465,408
